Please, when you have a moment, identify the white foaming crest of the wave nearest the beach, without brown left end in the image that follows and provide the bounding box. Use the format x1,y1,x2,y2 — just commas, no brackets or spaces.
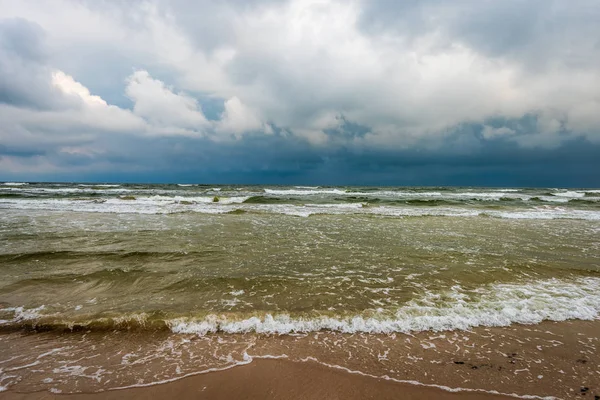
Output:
168,278,600,335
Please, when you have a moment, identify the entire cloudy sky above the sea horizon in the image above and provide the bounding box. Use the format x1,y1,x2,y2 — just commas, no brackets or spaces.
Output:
0,0,600,187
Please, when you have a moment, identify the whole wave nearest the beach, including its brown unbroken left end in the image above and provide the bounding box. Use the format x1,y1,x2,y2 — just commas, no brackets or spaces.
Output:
0,277,600,335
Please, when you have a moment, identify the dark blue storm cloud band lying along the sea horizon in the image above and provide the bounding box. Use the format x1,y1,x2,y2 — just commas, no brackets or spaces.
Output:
3,117,600,187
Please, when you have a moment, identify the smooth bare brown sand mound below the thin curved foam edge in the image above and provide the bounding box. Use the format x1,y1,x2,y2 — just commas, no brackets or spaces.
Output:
0,360,509,400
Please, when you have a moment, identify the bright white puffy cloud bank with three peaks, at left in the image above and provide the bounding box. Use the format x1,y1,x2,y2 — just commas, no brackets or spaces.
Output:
0,57,270,170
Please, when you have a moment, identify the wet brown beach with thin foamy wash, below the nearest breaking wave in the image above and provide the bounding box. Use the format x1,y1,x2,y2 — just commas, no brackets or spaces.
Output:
0,320,600,400
